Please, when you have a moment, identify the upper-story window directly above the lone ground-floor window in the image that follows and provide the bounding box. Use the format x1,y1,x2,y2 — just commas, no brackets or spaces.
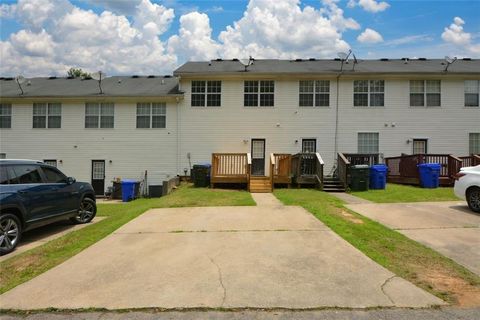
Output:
353,80,385,107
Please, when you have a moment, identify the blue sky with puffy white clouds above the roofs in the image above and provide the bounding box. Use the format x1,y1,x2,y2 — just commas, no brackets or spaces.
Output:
0,0,480,76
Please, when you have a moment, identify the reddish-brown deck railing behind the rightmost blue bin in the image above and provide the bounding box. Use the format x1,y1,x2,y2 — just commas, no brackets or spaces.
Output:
385,154,462,185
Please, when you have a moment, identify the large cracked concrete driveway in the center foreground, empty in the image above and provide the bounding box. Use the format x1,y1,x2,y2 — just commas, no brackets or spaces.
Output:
0,195,443,309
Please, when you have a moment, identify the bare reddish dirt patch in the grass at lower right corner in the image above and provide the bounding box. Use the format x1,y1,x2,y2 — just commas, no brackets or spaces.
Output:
418,269,480,307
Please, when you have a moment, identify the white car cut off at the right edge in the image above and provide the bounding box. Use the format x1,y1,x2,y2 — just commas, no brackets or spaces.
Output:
453,165,480,212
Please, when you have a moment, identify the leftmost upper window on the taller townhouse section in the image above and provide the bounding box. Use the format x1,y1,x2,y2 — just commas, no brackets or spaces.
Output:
191,81,222,107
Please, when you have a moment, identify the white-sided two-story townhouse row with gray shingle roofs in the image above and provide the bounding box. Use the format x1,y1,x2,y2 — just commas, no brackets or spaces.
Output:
0,59,480,194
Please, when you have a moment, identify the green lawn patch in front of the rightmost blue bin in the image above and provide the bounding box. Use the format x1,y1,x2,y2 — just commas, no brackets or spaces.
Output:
351,183,458,203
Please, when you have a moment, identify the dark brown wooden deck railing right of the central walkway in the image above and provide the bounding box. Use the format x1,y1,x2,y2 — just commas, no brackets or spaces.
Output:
292,152,324,188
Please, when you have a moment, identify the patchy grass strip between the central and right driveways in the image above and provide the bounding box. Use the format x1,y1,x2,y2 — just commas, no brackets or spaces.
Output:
274,189,480,306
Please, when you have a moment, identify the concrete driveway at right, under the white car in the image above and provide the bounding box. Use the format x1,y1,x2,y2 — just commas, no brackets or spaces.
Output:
347,201,480,275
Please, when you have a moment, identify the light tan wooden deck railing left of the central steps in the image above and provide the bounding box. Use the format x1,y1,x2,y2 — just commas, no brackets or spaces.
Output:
210,153,252,188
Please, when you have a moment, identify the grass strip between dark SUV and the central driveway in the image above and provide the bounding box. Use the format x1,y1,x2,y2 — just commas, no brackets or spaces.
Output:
0,184,255,294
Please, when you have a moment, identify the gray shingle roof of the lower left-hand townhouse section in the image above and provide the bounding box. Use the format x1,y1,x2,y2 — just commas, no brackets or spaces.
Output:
0,76,181,98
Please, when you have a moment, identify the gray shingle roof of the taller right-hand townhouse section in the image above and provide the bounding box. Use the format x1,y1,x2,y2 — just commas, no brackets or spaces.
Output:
173,59,480,76
